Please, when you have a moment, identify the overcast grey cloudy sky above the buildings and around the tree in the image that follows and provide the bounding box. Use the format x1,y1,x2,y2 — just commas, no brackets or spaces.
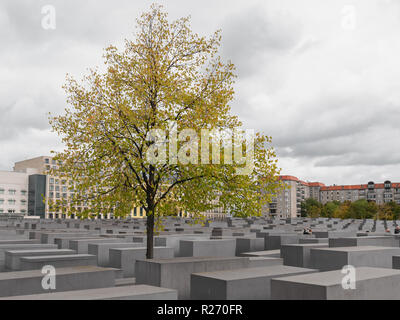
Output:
0,0,400,184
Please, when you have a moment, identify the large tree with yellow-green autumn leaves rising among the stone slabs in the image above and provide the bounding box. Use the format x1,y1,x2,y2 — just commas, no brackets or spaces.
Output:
50,5,280,259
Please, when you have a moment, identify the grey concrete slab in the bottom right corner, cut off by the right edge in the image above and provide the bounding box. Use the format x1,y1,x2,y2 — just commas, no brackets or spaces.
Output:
271,267,400,300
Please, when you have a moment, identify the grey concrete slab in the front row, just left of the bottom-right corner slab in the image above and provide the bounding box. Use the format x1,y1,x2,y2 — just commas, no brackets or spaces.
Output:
190,266,316,300
